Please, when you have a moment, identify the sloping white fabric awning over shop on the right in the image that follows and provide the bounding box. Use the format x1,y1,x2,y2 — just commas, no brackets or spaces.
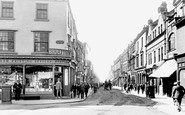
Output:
149,59,177,78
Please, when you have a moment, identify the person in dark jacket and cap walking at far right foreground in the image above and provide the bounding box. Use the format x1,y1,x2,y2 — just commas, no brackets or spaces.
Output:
172,81,185,112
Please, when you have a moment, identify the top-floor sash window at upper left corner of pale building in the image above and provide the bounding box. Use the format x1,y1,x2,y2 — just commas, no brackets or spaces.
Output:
2,2,13,18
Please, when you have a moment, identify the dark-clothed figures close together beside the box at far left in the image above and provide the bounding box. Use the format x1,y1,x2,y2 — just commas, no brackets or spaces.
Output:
13,80,22,101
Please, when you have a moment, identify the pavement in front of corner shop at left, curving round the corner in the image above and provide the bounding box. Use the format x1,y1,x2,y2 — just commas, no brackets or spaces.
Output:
0,89,93,106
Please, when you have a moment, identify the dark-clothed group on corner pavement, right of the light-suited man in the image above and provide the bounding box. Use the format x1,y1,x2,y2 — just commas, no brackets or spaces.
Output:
71,82,90,99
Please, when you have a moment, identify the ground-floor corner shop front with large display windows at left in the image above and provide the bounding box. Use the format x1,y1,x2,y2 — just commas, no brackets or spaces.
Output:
0,56,75,96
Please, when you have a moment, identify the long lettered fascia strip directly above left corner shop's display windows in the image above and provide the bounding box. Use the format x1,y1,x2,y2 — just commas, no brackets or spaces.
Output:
0,59,69,65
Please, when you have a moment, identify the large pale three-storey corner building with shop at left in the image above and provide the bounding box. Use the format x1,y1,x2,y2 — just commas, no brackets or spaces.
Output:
0,0,77,98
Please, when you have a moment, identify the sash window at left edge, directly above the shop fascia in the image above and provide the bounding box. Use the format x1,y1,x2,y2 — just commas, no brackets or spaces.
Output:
0,31,14,52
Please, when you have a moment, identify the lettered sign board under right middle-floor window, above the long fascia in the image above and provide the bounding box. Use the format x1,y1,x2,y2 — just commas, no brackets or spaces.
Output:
49,49,71,57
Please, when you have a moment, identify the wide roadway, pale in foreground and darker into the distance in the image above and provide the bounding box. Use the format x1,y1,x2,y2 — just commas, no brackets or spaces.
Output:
0,88,166,115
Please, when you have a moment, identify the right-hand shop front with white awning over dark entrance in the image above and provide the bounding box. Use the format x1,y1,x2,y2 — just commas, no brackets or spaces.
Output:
149,59,177,97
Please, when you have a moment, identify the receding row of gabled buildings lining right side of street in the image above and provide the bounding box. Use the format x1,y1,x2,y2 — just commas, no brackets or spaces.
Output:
111,0,185,96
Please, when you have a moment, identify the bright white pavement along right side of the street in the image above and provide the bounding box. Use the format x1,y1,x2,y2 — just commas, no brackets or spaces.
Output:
113,86,185,115
